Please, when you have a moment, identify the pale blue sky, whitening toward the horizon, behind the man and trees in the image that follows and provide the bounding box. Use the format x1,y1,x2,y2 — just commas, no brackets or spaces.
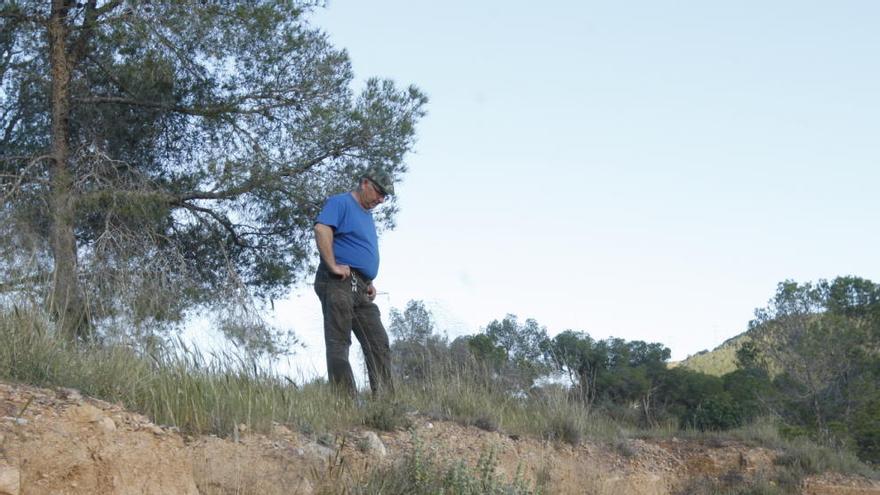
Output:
273,0,880,375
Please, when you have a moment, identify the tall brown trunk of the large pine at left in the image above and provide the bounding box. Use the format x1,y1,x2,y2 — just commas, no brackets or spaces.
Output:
49,0,88,340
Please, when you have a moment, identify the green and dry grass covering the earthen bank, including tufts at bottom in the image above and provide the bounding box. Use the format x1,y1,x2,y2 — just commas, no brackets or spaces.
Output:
0,310,871,493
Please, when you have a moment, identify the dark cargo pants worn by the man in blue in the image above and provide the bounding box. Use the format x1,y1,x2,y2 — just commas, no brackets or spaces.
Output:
315,263,394,396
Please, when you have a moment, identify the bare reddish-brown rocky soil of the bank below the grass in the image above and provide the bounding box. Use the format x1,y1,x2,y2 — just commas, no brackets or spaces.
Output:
0,383,880,495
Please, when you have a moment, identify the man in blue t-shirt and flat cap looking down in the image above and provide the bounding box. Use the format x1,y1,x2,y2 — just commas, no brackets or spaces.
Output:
315,171,394,396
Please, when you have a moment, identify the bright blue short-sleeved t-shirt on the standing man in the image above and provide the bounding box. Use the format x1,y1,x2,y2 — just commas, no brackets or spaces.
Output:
315,193,379,280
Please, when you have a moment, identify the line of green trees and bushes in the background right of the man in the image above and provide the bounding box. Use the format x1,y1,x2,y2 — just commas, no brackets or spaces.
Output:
389,277,880,463
